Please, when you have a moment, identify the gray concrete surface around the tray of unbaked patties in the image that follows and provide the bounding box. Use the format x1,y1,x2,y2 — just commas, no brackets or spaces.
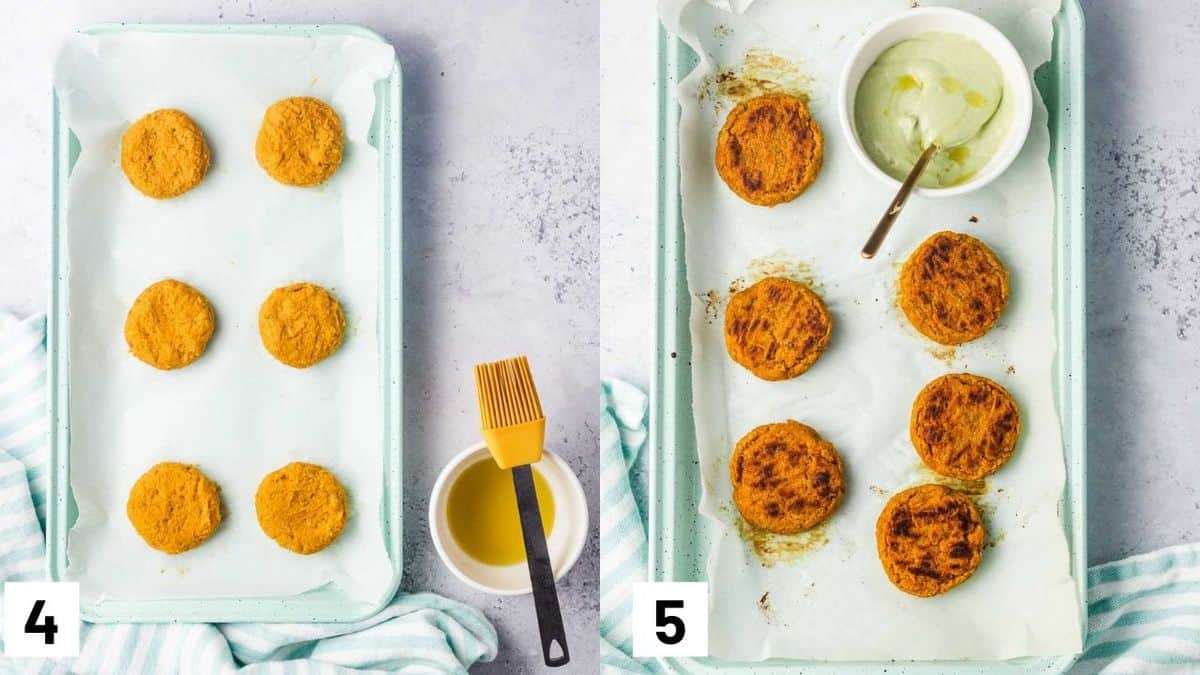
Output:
0,0,599,674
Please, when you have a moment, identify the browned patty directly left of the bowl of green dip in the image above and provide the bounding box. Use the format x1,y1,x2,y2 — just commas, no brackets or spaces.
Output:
716,94,824,207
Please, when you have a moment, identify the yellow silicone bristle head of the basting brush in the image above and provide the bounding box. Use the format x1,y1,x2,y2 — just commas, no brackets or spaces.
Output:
475,357,546,468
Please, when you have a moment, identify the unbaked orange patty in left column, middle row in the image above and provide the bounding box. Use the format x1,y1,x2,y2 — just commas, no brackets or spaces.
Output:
125,279,216,370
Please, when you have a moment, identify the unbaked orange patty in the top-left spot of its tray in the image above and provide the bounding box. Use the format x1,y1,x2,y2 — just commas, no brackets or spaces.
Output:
121,108,210,199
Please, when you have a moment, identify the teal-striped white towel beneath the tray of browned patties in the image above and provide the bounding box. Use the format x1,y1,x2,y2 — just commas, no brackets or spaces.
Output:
600,380,1200,675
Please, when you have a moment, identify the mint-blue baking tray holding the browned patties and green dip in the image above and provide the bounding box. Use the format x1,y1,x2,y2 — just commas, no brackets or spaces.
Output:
649,0,1087,675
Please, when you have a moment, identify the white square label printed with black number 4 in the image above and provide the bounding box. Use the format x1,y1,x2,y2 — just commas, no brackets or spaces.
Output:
4,581,79,657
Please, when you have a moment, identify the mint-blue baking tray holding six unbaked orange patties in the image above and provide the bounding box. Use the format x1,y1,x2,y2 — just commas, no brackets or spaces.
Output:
46,24,403,623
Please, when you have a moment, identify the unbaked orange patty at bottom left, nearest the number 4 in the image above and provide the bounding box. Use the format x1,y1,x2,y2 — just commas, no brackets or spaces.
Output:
125,461,221,554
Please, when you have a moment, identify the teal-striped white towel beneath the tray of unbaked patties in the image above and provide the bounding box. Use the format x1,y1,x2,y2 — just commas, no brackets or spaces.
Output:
0,313,497,675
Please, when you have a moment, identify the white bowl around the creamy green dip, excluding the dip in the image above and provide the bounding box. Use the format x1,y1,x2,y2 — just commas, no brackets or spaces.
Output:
838,7,1033,197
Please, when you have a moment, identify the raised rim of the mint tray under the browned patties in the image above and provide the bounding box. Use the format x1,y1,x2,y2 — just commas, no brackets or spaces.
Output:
647,0,1087,675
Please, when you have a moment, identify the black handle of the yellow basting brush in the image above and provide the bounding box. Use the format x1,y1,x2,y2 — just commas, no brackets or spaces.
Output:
512,465,571,668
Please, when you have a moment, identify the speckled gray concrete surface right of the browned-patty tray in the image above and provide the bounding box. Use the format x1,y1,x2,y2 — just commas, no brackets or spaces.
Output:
1084,0,1200,563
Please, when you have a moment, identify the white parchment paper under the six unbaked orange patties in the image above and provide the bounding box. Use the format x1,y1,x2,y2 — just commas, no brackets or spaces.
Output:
54,34,394,602
